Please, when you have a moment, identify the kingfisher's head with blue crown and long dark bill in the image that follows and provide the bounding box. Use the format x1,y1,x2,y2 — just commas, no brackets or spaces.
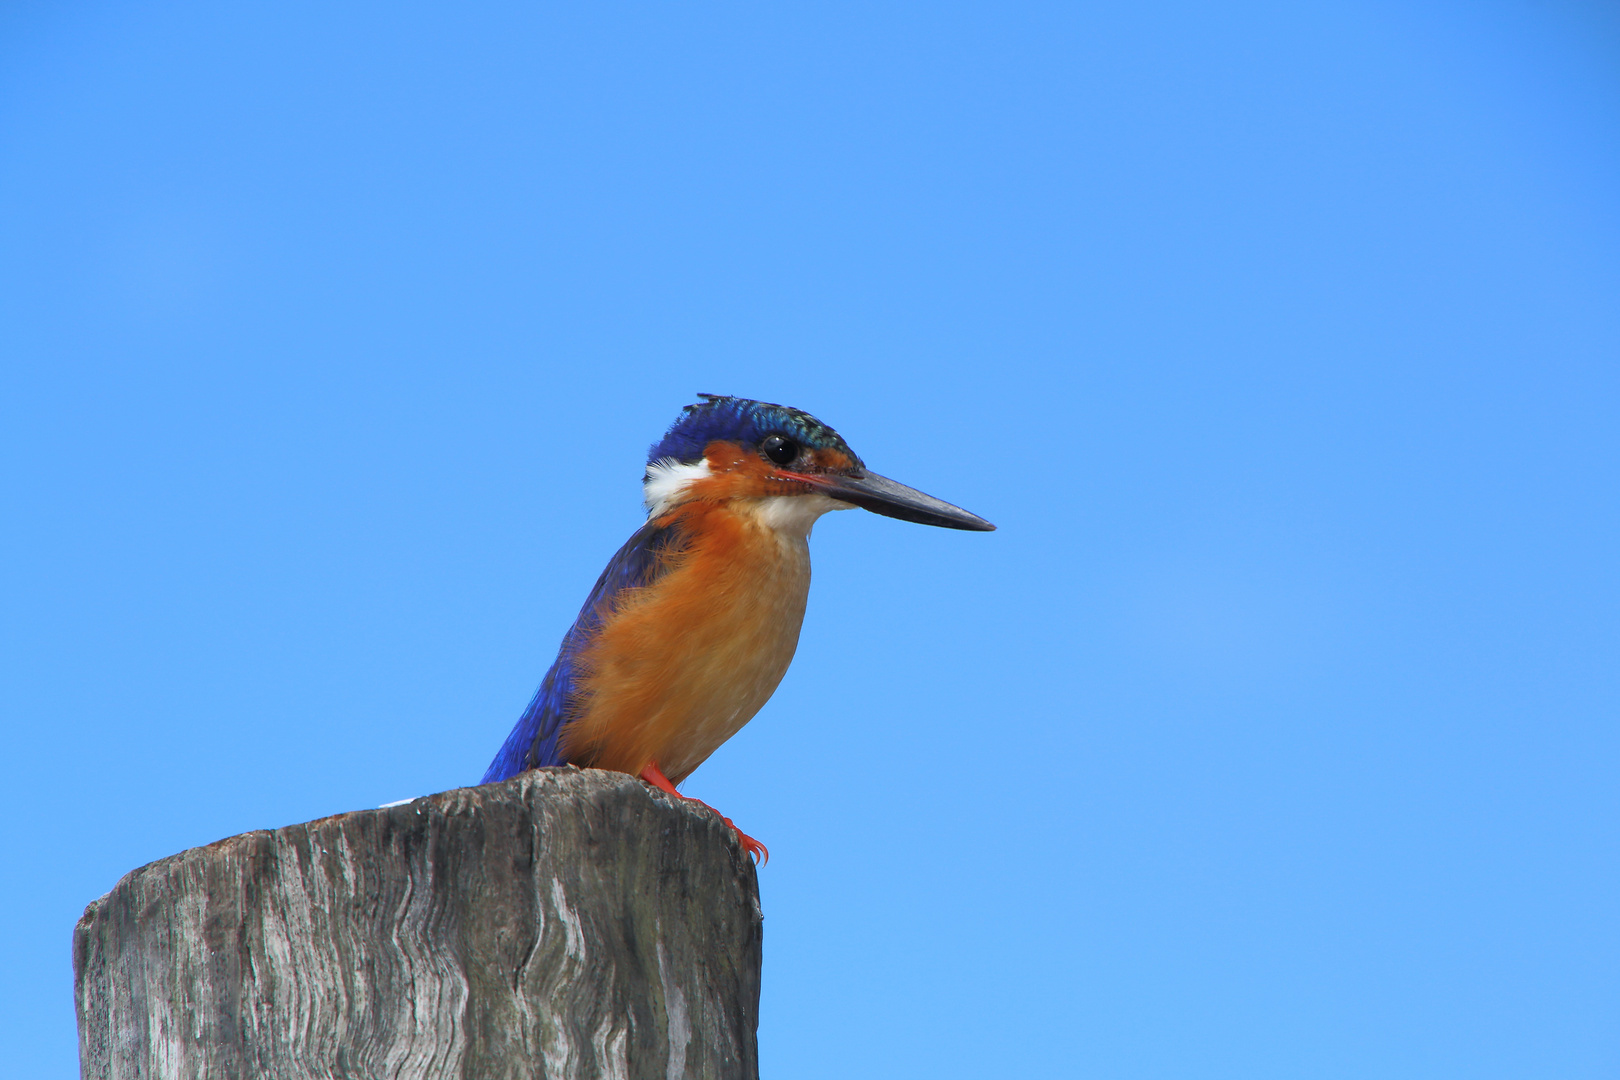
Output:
643,393,995,531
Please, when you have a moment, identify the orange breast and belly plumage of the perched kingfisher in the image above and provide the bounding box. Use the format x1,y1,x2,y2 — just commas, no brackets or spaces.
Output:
562,500,810,782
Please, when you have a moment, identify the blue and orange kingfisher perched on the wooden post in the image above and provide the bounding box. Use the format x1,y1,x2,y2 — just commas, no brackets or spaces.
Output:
483,393,995,861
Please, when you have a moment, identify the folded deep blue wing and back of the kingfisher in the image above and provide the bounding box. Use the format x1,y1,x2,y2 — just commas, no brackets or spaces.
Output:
480,520,680,784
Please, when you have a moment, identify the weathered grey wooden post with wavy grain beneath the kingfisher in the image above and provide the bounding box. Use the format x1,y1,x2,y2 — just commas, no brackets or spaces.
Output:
73,769,761,1080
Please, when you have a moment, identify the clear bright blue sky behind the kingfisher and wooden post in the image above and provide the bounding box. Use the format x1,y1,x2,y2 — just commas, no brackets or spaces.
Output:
0,0,1620,1080
